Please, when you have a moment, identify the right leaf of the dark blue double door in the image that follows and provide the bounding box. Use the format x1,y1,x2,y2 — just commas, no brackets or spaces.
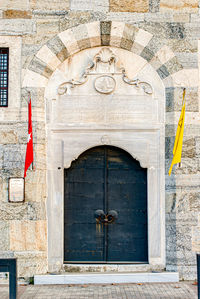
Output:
107,150,148,262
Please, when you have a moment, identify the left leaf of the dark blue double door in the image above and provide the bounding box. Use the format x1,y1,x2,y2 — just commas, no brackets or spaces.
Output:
64,149,105,262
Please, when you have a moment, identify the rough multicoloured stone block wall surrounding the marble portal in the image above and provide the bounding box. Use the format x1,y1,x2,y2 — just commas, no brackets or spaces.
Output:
0,0,200,279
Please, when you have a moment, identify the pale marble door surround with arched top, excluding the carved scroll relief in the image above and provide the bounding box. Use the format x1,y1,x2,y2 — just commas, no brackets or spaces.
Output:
45,47,165,272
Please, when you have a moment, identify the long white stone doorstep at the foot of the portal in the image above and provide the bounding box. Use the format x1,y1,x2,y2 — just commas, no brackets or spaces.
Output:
34,272,179,285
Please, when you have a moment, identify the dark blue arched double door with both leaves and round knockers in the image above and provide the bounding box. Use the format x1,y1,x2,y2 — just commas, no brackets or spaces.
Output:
64,146,148,263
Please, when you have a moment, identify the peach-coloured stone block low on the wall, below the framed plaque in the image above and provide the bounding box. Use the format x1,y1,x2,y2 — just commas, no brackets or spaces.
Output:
10,220,47,251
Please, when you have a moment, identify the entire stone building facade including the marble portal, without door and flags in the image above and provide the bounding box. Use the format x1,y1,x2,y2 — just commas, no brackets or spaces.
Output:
0,0,200,279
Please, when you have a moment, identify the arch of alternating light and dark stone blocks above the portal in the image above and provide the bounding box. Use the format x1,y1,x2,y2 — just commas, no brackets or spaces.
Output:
23,21,183,87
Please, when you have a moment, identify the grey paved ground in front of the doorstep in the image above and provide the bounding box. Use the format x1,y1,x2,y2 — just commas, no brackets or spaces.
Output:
0,282,197,299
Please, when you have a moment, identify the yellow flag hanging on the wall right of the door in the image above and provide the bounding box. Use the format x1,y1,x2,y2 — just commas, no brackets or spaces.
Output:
169,89,185,175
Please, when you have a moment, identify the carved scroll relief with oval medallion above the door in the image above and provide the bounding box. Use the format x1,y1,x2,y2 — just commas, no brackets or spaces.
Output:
58,48,153,95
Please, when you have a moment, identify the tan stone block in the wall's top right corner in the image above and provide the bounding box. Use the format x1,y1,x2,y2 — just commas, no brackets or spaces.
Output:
160,0,198,13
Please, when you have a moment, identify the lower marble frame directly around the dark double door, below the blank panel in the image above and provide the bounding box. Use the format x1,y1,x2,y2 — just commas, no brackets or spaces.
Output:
47,127,165,272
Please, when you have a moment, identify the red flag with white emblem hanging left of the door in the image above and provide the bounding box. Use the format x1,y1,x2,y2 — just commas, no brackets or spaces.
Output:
24,99,33,177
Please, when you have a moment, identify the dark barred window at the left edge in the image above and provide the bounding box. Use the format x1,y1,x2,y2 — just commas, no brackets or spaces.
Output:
0,48,9,107
